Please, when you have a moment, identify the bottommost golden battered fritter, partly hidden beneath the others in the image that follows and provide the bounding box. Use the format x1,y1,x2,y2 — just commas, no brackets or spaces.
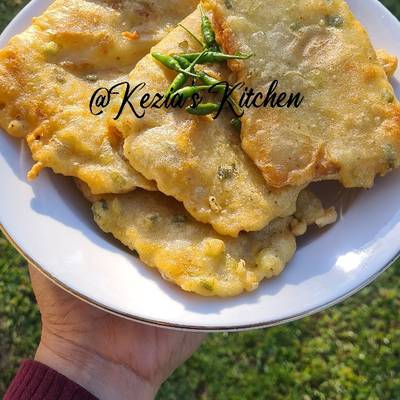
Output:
93,190,336,297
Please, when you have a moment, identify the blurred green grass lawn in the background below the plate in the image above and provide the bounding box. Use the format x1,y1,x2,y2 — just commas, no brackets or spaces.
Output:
0,0,400,400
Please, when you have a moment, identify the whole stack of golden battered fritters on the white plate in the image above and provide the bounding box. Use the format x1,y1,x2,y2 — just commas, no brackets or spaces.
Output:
0,0,400,297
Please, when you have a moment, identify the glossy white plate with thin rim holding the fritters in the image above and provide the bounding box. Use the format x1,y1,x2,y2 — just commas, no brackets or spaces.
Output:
0,0,400,330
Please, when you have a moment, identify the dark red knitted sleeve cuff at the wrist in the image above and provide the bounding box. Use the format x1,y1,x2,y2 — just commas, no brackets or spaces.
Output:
4,360,97,400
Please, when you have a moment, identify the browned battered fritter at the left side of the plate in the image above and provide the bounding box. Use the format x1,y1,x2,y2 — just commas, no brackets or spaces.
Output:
0,0,197,193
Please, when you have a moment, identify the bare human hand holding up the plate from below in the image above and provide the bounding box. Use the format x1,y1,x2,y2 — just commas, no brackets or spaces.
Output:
29,266,205,400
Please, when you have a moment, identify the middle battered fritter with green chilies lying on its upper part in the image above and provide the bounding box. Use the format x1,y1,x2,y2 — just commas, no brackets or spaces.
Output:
111,11,301,237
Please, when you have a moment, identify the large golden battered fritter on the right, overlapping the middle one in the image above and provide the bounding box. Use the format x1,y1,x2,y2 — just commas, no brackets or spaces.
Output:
204,0,400,188
